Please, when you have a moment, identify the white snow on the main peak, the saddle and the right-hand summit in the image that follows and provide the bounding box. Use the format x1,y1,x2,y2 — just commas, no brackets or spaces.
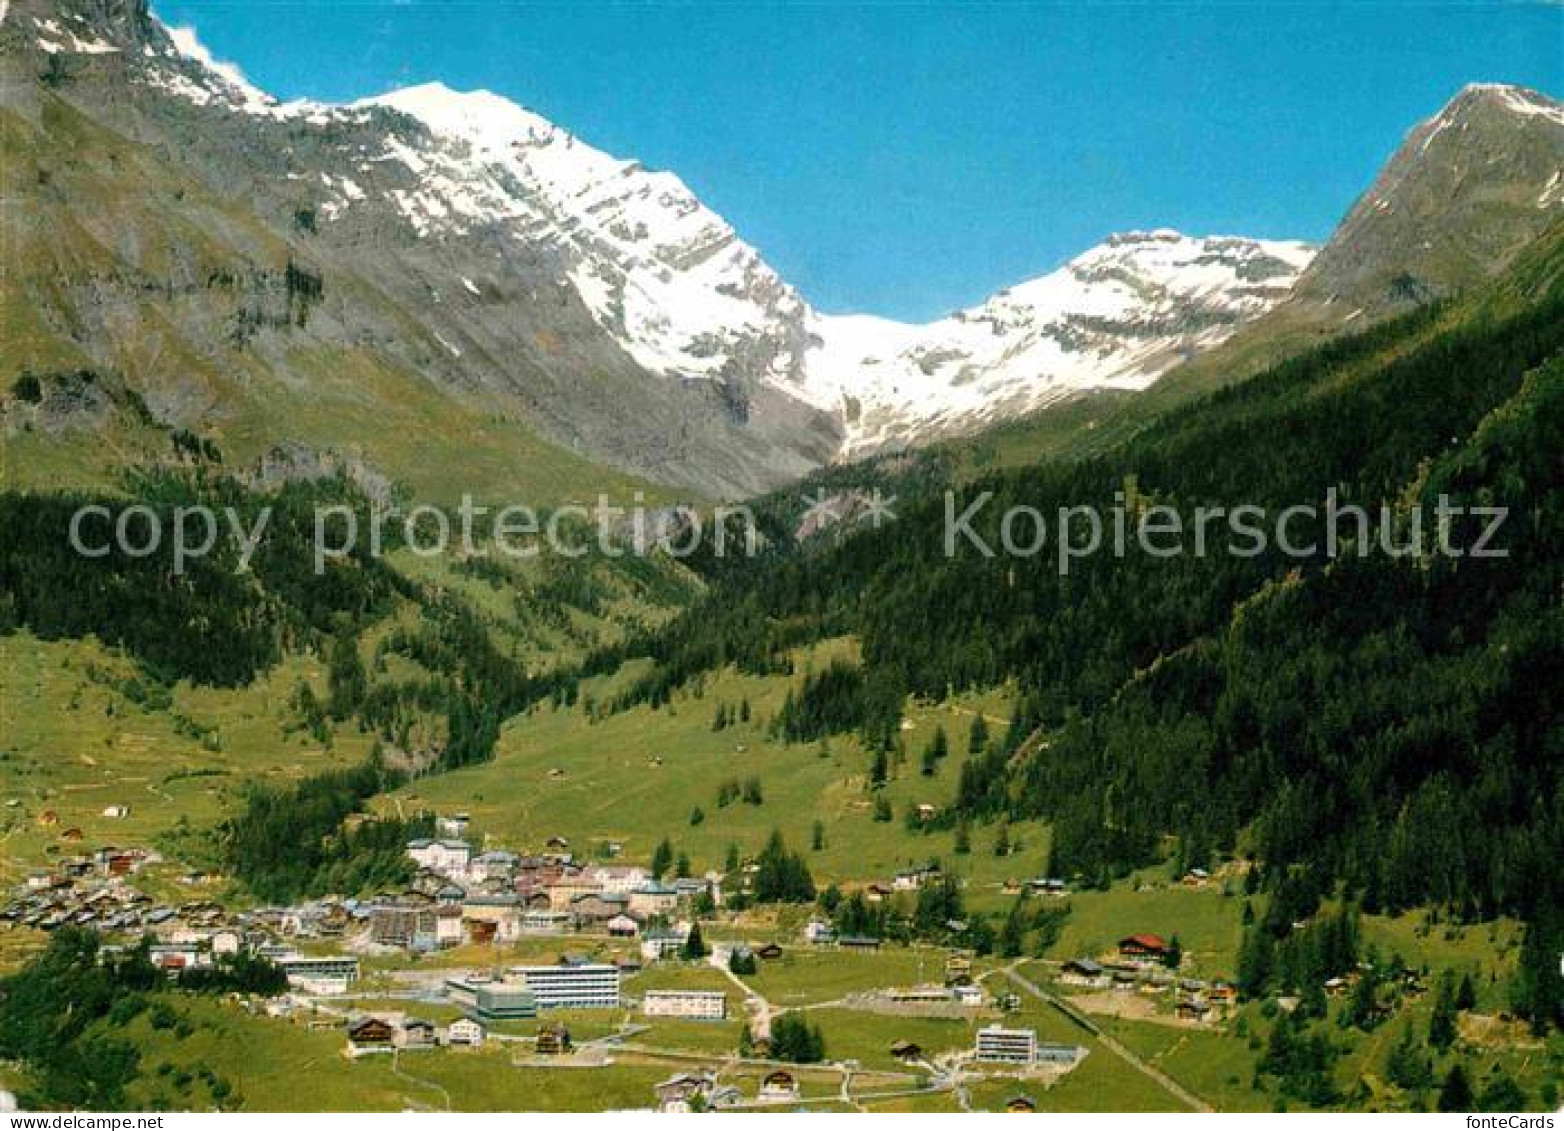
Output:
345,83,1312,455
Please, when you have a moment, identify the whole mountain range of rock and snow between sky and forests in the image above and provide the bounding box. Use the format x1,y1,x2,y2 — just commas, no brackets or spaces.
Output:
0,0,1564,496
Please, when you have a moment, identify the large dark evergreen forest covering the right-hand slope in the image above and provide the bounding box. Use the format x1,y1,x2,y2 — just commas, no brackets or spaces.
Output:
588,232,1564,1023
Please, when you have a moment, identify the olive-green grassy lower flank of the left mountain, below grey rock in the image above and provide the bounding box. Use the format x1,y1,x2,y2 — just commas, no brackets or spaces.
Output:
0,91,674,507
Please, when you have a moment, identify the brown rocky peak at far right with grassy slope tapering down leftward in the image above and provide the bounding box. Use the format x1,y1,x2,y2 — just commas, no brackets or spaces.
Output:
938,83,1564,463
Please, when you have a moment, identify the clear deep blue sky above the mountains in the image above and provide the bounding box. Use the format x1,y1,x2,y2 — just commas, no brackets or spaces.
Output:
155,0,1564,319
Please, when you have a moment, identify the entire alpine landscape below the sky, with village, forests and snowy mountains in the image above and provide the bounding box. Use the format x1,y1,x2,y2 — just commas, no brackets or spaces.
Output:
0,0,1564,1114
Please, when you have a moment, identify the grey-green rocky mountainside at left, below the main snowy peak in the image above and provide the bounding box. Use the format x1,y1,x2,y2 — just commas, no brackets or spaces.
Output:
0,0,841,501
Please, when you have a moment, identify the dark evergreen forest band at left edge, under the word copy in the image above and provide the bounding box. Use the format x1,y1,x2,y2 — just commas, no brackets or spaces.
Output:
0,469,411,687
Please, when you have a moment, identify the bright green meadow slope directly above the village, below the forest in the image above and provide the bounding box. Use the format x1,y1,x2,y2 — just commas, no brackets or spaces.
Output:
373,640,1048,906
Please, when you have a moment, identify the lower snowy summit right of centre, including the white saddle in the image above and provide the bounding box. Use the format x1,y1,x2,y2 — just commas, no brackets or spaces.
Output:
809,230,1314,454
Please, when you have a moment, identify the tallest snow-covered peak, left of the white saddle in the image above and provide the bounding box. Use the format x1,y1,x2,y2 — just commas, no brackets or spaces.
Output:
355,83,805,391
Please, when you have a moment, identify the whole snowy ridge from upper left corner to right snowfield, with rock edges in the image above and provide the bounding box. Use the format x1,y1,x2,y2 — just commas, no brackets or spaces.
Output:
30,0,1311,480
